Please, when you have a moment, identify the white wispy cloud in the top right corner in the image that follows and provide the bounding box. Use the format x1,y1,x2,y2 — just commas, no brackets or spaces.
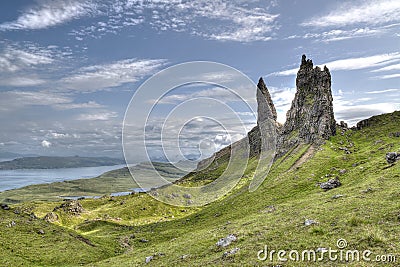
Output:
301,0,400,27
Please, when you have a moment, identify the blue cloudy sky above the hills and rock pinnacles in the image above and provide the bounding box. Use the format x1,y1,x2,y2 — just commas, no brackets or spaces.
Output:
0,0,400,161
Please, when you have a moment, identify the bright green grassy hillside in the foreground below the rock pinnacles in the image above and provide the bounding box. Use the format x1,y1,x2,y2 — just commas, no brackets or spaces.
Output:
0,112,400,266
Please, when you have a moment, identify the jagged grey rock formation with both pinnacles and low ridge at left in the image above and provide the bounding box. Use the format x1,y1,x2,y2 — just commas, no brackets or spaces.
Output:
197,55,336,170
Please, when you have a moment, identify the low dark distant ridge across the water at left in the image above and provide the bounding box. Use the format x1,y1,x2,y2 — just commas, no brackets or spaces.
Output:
0,156,125,170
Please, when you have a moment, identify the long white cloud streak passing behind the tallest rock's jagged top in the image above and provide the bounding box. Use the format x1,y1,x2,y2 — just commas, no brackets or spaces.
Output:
269,52,400,76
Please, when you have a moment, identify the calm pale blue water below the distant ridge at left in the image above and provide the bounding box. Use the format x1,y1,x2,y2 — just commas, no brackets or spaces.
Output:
0,165,125,192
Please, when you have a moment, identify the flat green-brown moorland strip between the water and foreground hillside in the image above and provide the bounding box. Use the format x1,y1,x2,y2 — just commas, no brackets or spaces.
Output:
0,162,184,203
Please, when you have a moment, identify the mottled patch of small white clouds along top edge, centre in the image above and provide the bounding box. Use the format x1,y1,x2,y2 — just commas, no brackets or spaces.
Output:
70,0,279,42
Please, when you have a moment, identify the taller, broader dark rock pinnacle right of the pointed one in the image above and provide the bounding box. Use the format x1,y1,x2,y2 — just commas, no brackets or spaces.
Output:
277,55,336,157
